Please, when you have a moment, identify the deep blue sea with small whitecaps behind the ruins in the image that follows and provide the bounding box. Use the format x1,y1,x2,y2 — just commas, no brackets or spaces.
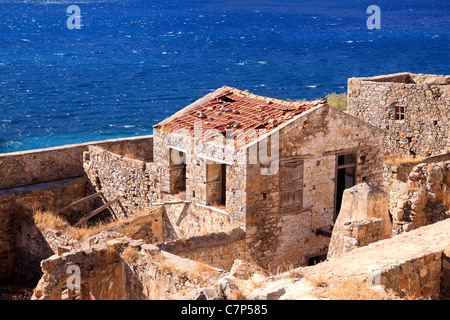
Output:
0,0,450,153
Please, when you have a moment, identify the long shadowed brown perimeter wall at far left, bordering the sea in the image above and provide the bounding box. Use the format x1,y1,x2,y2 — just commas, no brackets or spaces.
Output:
0,136,153,282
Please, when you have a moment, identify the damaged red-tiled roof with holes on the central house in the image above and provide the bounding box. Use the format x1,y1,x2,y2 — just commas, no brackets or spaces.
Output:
155,86,326,141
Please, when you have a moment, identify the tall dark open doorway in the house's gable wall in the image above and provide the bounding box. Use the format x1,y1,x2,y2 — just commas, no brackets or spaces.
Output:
334,153,356,220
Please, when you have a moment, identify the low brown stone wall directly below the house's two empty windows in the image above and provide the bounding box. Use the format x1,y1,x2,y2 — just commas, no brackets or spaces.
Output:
156,229,246,271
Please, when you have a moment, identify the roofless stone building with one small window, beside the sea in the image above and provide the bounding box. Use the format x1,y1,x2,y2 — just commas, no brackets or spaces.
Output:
348,72,450,157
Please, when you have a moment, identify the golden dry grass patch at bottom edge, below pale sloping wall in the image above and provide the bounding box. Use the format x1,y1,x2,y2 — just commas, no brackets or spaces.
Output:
324,278,396,300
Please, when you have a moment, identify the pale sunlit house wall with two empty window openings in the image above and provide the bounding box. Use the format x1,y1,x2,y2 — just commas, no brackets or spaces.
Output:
154,128,246,223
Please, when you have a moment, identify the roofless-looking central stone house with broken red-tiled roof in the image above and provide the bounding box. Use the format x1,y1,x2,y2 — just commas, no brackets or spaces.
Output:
153,86,383,268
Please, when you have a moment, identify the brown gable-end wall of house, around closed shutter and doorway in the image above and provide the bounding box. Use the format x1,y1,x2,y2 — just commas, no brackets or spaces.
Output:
246,106,383,268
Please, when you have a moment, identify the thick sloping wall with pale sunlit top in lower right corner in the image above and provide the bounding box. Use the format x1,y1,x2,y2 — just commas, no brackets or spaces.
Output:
312,219,450,299
